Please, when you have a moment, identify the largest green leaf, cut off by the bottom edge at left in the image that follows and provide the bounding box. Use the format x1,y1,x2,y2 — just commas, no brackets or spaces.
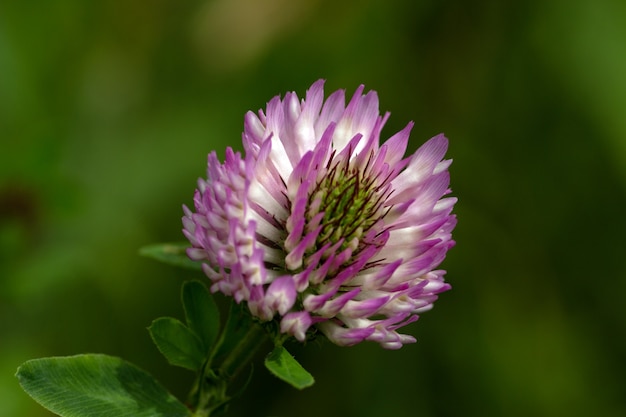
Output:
16,354,191,417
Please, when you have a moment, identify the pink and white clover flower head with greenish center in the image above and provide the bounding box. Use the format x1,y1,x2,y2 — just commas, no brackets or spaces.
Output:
183,80,456,349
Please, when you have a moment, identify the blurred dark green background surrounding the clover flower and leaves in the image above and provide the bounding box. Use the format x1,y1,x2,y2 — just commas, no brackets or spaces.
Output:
0,0,626,417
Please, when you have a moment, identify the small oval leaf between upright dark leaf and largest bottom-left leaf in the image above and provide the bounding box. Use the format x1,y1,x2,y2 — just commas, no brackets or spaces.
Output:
148,317,206,371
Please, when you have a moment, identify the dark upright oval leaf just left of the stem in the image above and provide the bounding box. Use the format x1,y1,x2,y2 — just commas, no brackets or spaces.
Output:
183,281,220,353
